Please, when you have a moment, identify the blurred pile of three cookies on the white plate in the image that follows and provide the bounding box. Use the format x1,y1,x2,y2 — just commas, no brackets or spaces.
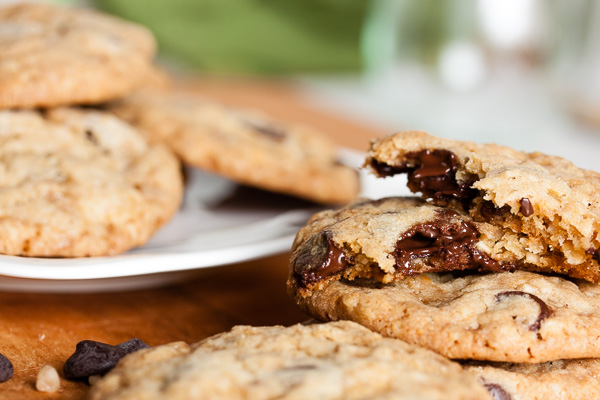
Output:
0,4,358,257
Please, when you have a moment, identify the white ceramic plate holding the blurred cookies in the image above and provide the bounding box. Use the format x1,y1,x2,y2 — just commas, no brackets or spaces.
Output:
0,150,406,292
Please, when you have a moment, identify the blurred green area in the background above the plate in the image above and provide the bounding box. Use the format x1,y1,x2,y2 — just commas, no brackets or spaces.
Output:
92,0,371,75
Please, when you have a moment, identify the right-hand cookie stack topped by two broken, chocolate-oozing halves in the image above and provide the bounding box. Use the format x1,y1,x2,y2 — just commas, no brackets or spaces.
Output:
288,132,600,399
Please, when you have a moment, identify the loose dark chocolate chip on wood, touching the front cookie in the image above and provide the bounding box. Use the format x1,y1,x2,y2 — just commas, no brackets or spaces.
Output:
63,338,149,379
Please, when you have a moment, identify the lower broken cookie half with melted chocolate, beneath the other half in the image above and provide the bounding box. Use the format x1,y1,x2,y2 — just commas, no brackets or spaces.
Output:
288,197,572,296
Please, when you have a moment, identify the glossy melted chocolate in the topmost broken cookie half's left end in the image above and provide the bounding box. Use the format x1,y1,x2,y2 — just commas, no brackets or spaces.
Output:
371,149,477,208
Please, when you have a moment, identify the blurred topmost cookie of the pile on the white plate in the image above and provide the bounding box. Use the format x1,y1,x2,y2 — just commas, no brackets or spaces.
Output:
0,3,156,108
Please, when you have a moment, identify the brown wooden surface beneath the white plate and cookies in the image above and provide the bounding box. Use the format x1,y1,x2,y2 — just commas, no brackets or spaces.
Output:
0,79,382,400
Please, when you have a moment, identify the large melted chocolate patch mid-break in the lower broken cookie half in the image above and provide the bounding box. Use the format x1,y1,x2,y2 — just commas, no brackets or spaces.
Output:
393,210,514,275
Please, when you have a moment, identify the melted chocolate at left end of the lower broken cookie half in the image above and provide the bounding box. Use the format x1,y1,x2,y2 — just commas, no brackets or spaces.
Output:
294,231,354,287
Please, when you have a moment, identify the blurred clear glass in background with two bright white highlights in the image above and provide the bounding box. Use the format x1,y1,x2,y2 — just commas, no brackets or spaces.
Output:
363,0,548,91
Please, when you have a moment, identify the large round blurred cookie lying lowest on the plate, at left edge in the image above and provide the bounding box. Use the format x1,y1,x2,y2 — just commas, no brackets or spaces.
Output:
0,108,183,257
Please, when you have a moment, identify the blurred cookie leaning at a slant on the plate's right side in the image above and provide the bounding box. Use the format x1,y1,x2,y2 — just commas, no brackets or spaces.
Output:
110,90,359,203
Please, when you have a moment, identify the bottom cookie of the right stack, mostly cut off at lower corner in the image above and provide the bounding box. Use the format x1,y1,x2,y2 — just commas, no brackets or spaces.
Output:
464,358,600,400
